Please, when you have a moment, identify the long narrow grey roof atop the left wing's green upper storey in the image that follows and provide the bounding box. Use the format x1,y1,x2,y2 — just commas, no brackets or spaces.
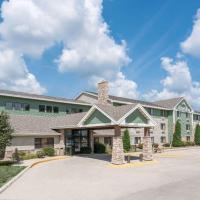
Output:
0,90,90,105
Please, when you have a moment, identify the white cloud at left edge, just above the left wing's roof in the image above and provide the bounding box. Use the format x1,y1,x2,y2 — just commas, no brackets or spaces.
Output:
0,49,46,94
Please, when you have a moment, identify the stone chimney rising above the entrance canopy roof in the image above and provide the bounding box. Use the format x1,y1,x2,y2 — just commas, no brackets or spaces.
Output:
98,81,109,105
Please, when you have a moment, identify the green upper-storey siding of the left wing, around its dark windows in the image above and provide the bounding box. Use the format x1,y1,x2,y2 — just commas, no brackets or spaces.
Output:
0,96,90,115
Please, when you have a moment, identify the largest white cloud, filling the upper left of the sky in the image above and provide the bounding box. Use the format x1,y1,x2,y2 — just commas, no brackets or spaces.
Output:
0,0,134,94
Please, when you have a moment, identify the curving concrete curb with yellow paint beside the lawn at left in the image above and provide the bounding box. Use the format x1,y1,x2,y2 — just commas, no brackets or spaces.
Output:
0,156,68,194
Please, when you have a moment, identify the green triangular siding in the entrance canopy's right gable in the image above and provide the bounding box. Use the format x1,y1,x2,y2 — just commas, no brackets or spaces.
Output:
125,109,148,124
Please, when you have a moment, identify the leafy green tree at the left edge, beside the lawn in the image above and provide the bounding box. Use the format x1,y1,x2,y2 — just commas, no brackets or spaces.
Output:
0,111,14,158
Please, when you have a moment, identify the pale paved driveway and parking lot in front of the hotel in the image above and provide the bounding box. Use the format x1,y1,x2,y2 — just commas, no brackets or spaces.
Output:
0,149,200,200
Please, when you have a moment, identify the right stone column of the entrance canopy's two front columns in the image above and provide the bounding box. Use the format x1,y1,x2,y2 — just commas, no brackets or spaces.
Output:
143,128,153,161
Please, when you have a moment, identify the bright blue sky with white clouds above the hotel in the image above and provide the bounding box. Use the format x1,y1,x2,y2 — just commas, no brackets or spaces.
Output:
0,0,200,108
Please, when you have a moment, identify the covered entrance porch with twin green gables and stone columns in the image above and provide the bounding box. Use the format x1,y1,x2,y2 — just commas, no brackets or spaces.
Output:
56,104,155,164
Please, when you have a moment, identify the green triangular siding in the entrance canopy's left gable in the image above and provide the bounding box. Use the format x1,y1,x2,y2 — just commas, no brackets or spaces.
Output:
84,110,111,125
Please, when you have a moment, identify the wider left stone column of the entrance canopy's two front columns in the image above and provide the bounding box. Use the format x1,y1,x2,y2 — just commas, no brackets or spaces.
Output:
111,126,124,165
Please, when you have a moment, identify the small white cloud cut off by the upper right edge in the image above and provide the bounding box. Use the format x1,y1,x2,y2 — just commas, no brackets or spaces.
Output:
181,9,200,57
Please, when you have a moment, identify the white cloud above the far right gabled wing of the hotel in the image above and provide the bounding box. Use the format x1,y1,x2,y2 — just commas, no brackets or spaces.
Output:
143,57,200,109
